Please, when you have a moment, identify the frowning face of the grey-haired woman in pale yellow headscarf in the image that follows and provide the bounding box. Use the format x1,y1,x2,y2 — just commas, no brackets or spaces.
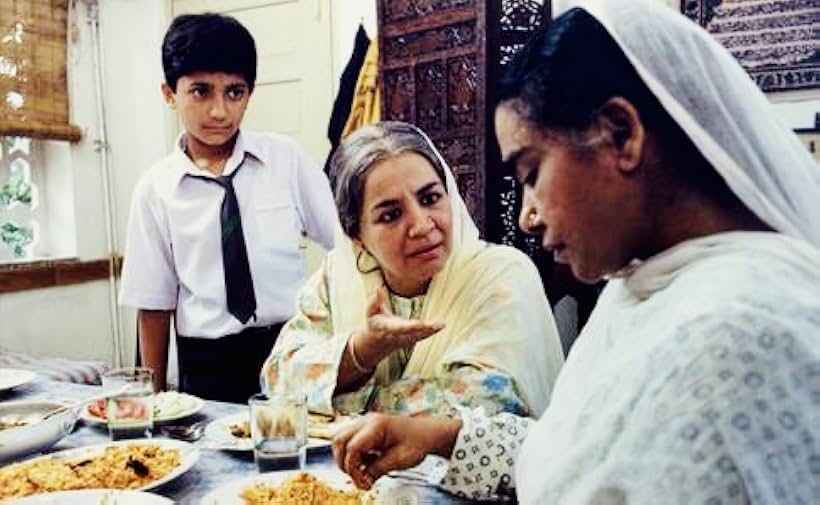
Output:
354,152,452,296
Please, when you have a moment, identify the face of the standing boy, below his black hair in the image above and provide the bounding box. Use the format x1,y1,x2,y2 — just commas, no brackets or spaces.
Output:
162,72,251,148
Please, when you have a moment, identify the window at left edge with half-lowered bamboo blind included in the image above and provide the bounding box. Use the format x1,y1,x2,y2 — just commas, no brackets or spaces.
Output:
0,0,80,264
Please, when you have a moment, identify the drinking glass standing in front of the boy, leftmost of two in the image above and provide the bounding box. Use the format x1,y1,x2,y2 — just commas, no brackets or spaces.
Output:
102,367,154,440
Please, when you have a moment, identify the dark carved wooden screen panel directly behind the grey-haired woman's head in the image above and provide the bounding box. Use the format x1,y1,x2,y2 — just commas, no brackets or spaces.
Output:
378,0,487,231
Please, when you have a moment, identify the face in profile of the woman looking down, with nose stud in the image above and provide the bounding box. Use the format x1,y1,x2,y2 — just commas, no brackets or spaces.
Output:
495,105,646,283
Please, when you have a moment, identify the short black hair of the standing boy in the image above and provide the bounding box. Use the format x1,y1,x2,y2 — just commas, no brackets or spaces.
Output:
162,13,256,91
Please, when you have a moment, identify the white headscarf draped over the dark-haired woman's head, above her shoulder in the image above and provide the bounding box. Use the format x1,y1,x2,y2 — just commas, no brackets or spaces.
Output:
554,0,820,247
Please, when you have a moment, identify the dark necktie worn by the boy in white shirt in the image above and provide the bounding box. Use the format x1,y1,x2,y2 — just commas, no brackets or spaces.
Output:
194,167,256,324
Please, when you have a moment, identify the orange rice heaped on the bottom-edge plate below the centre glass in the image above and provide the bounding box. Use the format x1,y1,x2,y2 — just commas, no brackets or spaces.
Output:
240,472,373,505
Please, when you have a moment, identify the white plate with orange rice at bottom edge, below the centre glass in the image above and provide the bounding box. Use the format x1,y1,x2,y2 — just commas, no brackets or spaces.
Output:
200,468,378,505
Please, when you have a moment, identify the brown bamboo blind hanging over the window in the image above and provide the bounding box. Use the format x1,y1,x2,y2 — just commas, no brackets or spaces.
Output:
0,0,81,141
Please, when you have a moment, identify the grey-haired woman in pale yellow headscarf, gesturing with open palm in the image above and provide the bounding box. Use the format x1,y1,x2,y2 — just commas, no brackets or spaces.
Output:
262,122,563,416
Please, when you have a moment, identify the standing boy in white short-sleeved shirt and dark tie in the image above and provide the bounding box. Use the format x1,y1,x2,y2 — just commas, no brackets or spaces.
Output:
120,14,336,403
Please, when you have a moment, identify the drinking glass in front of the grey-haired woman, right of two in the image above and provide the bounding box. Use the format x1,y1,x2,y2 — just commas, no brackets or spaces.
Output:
248,393,307,472
